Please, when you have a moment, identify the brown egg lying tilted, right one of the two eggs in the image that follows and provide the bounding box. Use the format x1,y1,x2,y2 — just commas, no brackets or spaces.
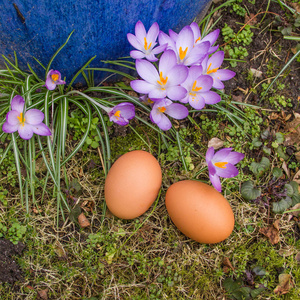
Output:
165,180,234,244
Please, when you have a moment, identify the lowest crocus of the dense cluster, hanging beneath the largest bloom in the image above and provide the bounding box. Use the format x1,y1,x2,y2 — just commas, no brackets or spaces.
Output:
150,99,189,130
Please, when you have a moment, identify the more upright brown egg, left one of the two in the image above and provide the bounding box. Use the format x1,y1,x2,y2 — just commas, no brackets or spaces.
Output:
104,150,162,219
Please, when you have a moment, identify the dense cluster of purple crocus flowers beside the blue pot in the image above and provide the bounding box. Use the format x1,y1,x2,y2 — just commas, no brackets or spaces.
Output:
127,21,235,130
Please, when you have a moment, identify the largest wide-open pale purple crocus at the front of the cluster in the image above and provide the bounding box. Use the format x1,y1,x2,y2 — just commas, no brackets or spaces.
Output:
130,50,188,100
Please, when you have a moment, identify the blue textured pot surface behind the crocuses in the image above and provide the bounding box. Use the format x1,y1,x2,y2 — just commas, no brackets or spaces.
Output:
0,0,209,82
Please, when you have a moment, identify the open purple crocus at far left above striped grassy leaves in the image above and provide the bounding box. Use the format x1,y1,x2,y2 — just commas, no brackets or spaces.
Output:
2,95,51,140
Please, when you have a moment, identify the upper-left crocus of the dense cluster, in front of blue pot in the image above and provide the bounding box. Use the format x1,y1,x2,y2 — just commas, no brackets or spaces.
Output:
127,21,166,61
